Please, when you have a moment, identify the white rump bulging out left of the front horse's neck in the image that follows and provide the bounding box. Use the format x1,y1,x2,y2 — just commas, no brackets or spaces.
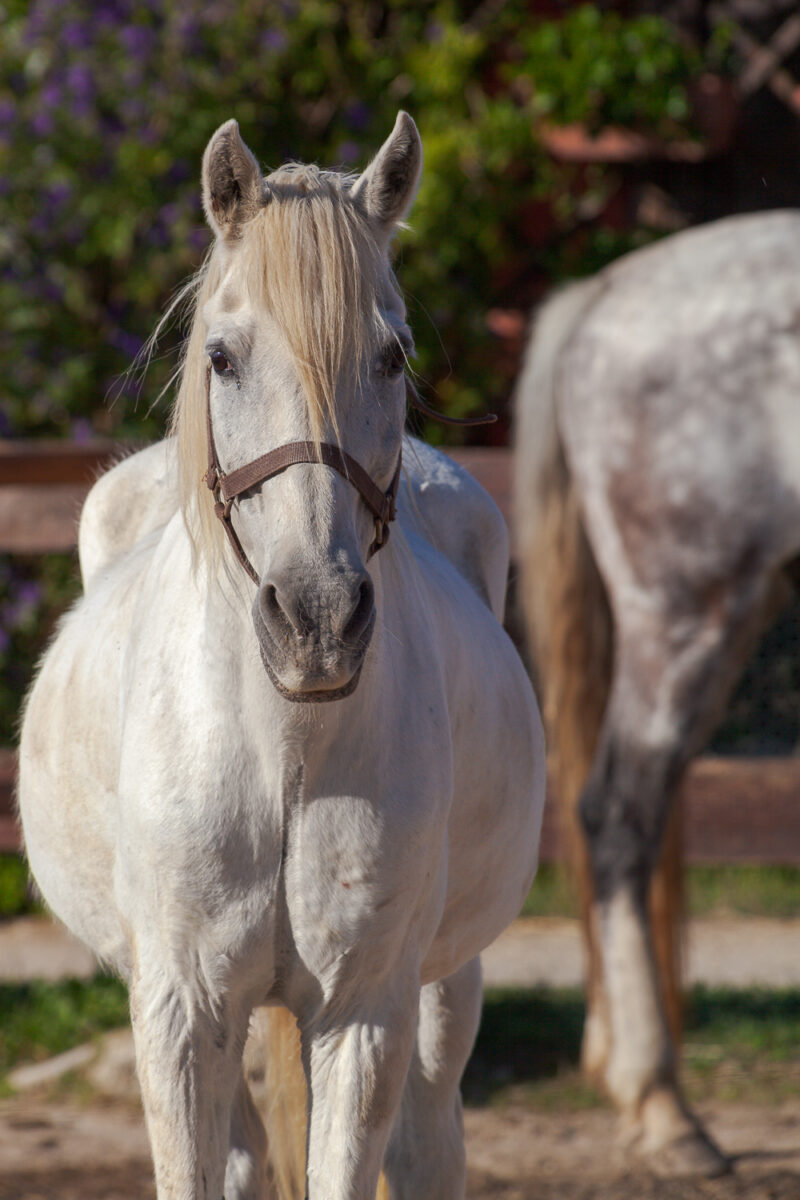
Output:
78,439,179,588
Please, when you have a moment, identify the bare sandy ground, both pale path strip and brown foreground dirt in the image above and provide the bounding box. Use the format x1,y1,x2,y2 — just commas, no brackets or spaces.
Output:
0,918,800,1200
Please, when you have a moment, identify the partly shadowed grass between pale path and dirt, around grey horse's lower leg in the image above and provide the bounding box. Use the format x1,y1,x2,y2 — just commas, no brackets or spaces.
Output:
463,986,800,1111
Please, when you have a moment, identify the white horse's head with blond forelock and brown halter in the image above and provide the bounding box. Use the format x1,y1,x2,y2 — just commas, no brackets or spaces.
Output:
178,113,422,700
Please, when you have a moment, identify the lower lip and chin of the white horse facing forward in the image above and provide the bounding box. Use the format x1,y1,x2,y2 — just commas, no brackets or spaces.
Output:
255,612,375,704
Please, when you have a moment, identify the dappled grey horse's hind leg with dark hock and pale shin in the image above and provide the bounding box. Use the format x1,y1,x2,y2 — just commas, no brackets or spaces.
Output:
581,578,768,1175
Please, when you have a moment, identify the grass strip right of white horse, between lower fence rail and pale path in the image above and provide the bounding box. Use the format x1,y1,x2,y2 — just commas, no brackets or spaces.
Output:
522,863,800,918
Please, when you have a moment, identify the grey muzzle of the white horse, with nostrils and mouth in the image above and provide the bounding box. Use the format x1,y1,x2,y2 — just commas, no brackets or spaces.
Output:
253,571,375,703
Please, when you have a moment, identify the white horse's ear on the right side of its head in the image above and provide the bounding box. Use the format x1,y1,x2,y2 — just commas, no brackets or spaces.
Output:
353,112,422,234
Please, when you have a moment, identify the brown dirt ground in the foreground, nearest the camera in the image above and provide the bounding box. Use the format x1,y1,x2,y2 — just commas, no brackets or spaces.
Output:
0,1093,800,1200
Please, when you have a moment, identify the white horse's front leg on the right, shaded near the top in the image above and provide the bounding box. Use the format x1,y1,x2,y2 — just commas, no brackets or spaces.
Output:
301,964,420,1200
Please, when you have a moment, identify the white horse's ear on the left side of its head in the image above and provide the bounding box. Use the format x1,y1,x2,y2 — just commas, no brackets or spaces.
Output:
203,120,264,241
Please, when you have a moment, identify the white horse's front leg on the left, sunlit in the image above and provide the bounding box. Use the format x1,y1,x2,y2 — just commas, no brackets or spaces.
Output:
131,946,248,1200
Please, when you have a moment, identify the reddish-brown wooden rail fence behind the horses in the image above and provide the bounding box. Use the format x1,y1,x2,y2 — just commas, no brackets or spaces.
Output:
0,442,800,863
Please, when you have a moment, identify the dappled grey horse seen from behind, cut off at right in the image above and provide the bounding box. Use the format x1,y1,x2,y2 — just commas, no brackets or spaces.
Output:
516,212,800,1172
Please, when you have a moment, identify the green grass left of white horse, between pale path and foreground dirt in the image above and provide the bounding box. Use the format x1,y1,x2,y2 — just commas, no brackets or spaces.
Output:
0,974,128,1078
